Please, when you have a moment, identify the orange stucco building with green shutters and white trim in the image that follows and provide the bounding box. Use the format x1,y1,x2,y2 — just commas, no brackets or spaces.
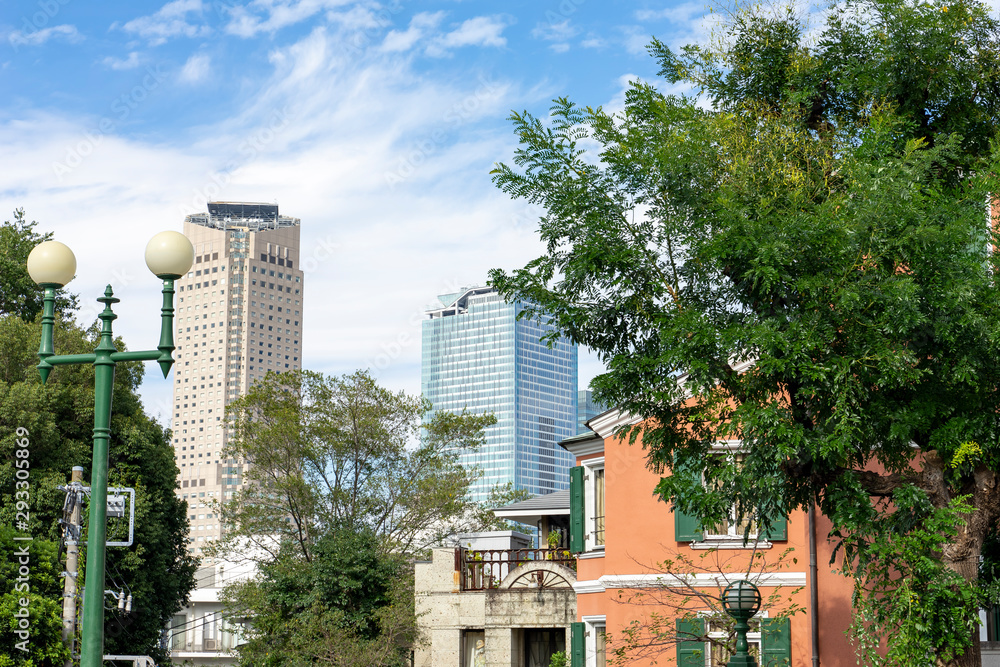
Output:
562,410,856,667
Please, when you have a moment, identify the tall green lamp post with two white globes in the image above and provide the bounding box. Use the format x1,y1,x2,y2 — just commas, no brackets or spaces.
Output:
28,232,194,667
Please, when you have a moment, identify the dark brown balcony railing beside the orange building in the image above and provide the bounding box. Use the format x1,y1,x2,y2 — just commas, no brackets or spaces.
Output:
455,548,576,591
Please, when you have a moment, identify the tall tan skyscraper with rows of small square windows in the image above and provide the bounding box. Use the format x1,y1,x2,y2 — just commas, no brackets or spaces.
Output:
173,202,304,556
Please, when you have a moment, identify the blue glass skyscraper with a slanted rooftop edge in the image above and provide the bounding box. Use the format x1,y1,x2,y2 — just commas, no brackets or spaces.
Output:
420,287,577,501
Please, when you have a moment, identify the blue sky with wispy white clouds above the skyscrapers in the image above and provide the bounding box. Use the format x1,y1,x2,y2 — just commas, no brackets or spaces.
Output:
0,0,707,421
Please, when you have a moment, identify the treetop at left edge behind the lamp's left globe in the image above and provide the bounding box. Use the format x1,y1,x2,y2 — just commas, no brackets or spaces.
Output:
0,208,77,322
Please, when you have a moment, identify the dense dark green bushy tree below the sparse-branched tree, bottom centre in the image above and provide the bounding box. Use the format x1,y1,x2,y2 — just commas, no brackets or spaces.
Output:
223,527,417,667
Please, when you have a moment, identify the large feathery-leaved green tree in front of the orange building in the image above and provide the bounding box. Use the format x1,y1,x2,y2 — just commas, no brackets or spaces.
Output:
491,0,1000,665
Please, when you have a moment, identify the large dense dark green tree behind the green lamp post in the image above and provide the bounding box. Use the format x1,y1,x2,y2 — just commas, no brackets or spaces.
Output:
0,315,195,664
